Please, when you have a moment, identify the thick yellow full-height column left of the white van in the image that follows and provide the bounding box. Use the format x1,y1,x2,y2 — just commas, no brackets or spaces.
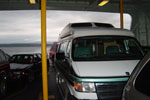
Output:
41,0,48,100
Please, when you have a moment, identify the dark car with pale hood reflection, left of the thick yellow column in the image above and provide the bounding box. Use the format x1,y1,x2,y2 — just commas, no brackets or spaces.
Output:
10,54,41,82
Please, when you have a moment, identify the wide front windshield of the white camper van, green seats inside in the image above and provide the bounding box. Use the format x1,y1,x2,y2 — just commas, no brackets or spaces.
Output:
72,36,143,61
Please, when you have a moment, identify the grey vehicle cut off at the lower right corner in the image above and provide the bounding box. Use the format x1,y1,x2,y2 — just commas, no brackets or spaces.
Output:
122,52,150,100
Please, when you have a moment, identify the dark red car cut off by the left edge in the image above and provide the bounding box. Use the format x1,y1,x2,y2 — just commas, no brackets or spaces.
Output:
0,49,10,96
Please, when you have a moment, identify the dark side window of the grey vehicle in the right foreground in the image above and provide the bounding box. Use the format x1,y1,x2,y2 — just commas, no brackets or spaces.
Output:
135,61,150,96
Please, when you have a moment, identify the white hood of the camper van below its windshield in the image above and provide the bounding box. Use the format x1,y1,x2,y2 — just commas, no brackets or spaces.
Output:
73,60,139,77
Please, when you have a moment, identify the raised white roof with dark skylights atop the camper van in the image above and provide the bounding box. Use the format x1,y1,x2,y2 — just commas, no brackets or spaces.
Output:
59,22,134,40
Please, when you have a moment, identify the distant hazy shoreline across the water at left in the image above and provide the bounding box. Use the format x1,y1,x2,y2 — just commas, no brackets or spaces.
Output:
0,43,52,47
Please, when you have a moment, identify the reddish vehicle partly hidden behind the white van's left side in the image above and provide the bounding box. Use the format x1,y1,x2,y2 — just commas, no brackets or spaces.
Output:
49,42,58,66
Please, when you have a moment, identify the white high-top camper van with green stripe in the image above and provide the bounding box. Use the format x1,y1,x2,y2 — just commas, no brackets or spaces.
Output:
55,23,144,100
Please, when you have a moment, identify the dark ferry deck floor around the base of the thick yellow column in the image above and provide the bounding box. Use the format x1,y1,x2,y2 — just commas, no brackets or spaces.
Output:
0,69,62,100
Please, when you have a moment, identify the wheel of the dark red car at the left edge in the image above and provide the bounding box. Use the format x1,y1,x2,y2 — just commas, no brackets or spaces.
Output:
0,79,7,96
